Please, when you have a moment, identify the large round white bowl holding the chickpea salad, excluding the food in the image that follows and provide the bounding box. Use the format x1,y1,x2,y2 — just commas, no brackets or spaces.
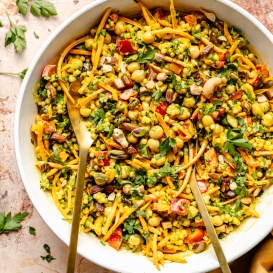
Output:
14,0,273,273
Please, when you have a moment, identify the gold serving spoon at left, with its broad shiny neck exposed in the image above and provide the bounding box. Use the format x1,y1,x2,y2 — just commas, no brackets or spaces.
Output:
66,81,94,273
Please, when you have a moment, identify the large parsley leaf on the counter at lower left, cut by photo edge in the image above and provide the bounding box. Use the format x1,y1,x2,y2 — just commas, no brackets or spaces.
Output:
0,211,28,234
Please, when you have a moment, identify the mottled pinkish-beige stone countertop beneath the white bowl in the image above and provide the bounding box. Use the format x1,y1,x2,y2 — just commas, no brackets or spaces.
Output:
0,0,273,273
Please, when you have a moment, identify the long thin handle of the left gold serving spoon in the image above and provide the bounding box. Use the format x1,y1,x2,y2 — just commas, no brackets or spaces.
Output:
66,147,89,273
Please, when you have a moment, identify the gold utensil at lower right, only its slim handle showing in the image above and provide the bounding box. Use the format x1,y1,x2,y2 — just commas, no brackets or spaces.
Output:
190,167,231,273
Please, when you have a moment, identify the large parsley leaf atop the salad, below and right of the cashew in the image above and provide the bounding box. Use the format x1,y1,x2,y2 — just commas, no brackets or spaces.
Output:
224,129,253,156
